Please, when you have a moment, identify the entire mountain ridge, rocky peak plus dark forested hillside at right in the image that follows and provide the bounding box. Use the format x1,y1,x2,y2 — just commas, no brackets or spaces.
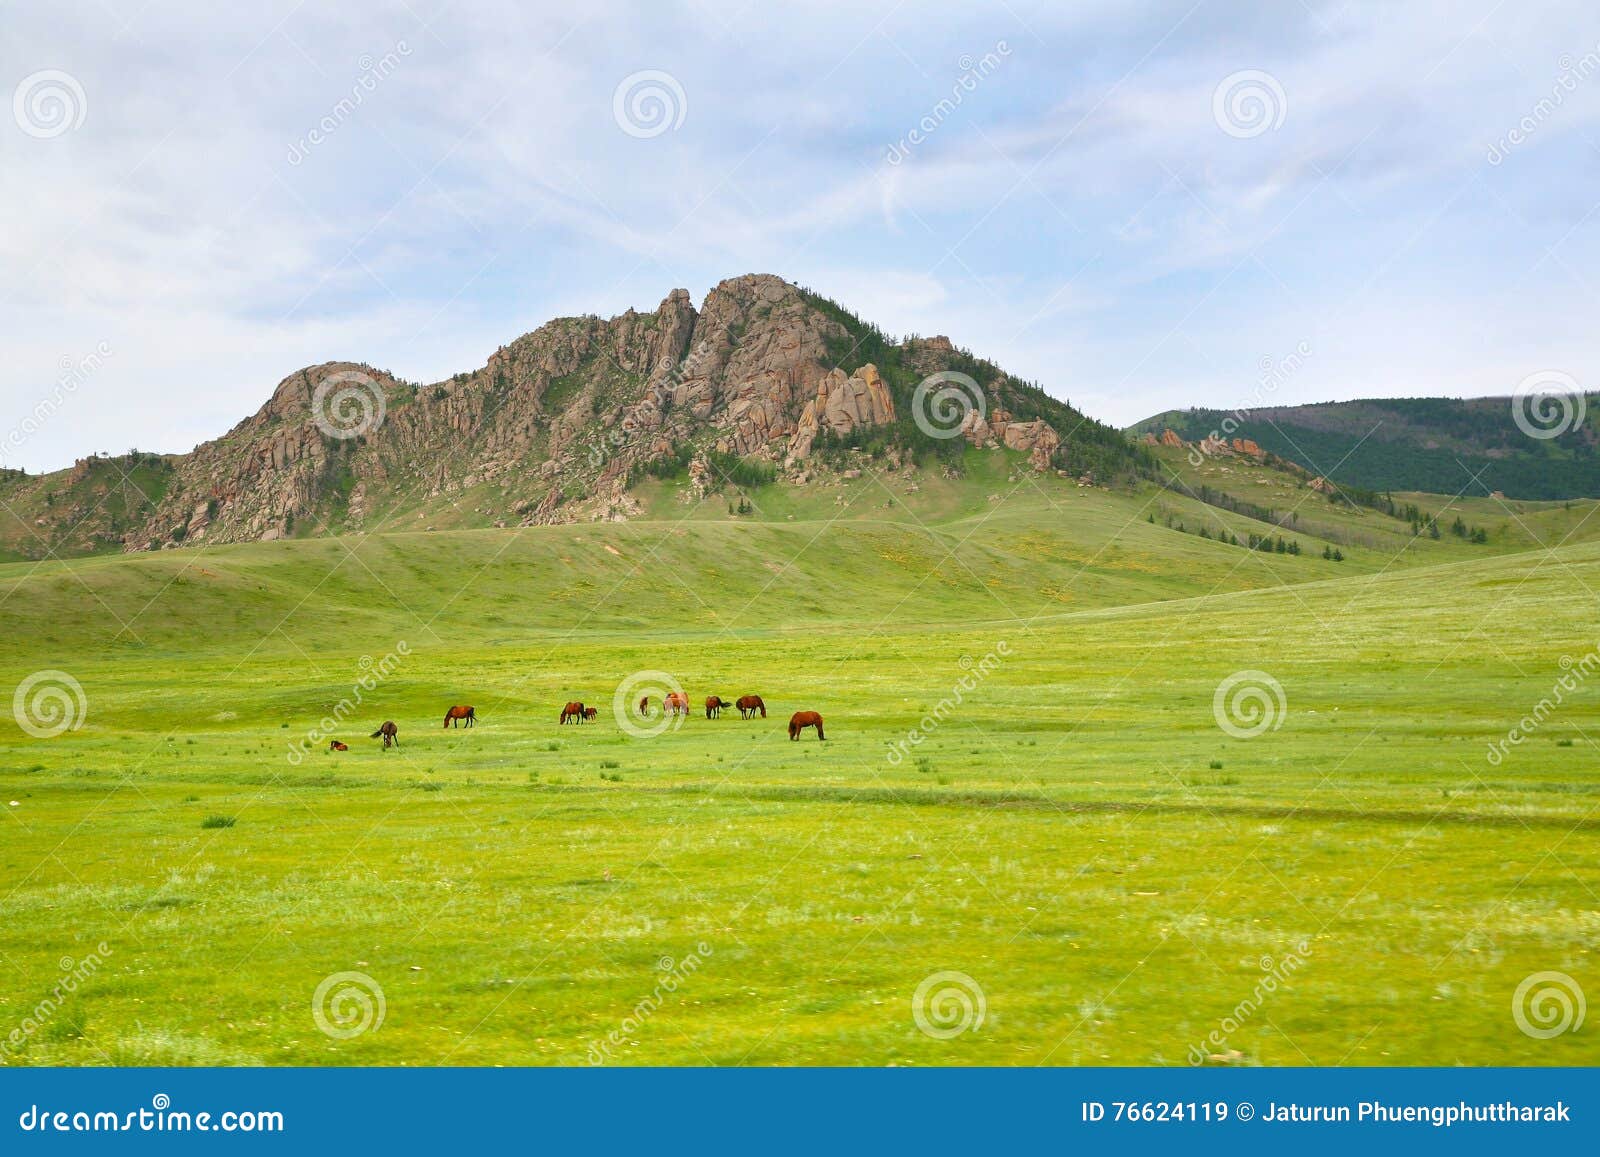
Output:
15,274,1600,560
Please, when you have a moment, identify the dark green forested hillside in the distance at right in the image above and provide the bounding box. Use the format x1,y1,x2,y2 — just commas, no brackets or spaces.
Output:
1131,397,1600,499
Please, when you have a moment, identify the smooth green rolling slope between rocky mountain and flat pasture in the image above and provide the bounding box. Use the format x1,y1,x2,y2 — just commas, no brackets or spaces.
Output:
0,435,1600,663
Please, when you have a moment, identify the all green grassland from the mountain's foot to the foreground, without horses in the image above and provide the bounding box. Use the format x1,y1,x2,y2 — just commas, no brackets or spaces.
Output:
0,454,1600,1064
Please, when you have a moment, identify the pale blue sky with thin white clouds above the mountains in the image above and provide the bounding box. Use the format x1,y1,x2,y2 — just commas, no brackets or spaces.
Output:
0,0,1600,470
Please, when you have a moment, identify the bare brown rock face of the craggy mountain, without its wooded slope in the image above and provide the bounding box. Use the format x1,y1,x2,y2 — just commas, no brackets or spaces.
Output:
0,274,1120,550
